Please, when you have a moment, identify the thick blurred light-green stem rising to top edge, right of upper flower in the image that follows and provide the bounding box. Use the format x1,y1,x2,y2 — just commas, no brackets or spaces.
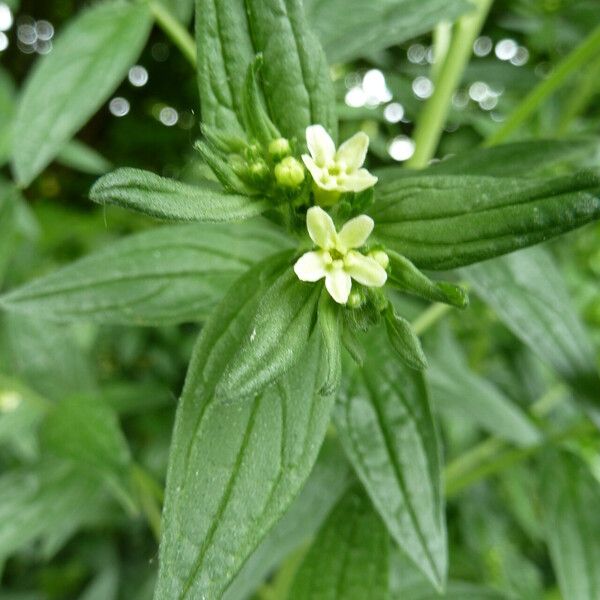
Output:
406,0,493,169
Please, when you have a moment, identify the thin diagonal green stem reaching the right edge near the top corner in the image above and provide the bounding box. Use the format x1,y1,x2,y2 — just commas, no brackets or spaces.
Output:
485,25,600,146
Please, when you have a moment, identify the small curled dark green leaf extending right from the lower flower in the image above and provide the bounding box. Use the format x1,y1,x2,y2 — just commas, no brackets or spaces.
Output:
387,250,469,308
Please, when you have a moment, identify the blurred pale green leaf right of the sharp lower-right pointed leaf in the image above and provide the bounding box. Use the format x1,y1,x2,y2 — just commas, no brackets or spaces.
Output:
426,335,540,446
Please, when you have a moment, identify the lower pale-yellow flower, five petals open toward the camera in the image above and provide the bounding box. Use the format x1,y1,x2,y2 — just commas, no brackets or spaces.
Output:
294,206,387,304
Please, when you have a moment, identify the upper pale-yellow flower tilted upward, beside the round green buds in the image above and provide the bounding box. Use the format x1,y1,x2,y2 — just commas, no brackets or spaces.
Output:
302,125,377,192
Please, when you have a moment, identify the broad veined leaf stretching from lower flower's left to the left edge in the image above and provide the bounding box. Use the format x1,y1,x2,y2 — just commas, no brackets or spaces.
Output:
0,221,290,325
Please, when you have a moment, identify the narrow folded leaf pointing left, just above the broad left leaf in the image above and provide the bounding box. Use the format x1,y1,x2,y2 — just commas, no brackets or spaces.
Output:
90,168,268,223
